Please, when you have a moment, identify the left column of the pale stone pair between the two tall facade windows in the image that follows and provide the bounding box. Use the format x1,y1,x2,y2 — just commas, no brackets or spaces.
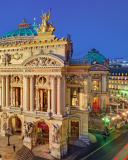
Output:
24,76,29,111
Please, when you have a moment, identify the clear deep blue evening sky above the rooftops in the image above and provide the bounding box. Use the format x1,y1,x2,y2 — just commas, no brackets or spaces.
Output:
0,0,128,58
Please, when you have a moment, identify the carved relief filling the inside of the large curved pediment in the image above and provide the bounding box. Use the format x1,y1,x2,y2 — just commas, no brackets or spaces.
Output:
25,57,61,67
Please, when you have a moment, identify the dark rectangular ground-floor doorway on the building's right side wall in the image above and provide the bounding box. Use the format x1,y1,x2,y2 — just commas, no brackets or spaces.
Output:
71,121,79,137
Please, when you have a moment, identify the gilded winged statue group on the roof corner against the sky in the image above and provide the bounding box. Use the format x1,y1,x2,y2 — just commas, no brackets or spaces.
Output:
36,9,55,35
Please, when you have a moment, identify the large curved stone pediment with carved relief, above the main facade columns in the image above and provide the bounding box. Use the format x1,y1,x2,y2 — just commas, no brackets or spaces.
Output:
22,55,64,67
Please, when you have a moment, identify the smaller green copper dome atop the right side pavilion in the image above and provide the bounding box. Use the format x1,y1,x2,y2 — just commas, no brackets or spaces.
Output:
84,48,106,63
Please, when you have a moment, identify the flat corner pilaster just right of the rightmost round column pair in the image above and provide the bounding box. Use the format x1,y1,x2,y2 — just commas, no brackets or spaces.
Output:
61,75,66,115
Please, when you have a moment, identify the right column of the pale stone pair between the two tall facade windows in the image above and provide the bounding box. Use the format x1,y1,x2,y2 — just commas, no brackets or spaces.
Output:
30,76,35,112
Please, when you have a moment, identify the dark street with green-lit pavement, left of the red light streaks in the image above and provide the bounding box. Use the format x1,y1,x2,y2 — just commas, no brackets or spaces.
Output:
63,127,128,160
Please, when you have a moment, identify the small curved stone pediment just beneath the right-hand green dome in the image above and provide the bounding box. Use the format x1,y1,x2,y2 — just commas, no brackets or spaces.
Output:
89,64,109,71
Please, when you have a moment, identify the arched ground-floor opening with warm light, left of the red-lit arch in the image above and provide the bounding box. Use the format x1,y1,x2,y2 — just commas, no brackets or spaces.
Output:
8,116,22,135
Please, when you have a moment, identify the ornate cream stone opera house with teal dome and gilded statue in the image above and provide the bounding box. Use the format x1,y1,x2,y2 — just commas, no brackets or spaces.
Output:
0,10,109,158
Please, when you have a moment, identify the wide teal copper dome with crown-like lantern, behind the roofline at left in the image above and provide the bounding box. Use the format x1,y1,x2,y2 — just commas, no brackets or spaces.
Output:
0,19,38,38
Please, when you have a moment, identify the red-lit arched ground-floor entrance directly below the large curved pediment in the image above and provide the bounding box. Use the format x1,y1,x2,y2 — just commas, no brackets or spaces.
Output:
37,122,49,144
